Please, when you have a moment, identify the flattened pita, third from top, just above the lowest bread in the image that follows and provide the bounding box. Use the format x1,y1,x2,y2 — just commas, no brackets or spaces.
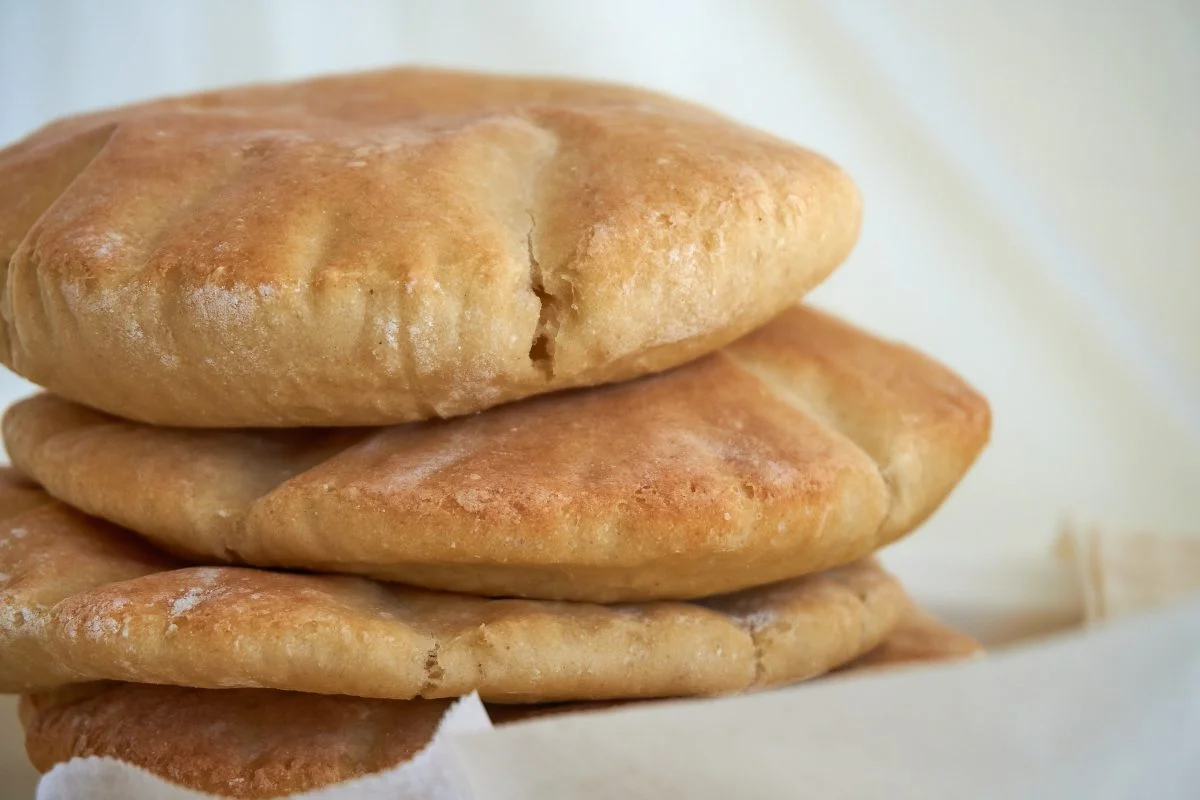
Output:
0,496,907,703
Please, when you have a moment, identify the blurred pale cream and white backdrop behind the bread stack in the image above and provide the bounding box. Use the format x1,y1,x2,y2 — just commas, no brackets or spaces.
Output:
0,0,1200,796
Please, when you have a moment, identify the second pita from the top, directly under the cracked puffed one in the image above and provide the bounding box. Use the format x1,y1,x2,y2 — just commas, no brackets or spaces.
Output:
4,307,990,602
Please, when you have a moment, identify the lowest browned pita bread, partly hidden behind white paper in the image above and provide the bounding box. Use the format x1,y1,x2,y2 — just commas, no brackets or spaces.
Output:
22,612,968,798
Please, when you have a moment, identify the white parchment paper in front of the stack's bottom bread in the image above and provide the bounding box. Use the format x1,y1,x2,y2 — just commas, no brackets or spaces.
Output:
30,599,1200,800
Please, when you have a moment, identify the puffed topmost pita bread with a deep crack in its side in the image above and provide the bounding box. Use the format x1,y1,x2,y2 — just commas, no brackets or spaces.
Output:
0,70,860,427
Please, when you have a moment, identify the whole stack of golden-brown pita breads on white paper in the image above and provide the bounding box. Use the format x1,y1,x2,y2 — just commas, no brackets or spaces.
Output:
0,70,990,796
